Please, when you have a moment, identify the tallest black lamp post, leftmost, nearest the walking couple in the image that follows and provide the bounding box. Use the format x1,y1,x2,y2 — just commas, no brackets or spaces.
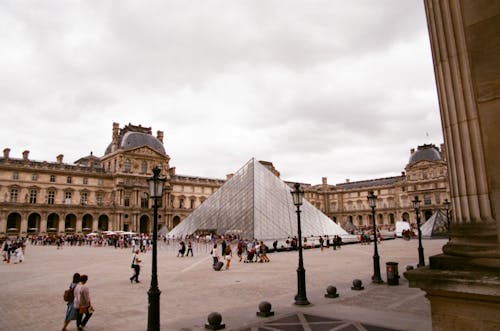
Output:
148,166,165,331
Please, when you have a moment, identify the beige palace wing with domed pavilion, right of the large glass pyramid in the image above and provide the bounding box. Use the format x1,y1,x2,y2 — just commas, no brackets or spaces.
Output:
305,145,450,229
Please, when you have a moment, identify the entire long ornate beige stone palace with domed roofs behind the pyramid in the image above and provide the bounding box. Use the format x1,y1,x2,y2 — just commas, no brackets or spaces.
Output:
0,123,449,237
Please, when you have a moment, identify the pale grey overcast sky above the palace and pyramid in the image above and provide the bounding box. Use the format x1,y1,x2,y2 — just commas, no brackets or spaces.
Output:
0,0,443,184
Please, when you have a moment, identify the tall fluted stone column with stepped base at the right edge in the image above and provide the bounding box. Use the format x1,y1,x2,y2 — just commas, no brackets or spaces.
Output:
405,0,500,330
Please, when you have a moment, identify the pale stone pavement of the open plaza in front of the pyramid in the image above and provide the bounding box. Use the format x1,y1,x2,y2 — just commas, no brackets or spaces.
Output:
0,239,446,331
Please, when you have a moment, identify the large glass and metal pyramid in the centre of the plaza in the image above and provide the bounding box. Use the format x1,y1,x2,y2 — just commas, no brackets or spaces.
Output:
168,159,347,240
